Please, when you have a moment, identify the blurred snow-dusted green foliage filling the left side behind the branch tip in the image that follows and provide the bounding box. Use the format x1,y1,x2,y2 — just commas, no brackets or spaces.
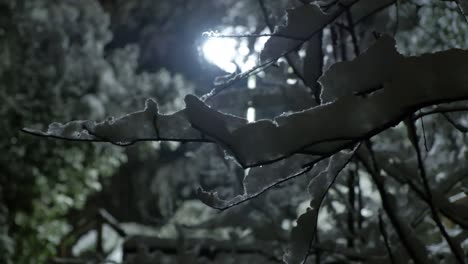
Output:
0,0,191,263
